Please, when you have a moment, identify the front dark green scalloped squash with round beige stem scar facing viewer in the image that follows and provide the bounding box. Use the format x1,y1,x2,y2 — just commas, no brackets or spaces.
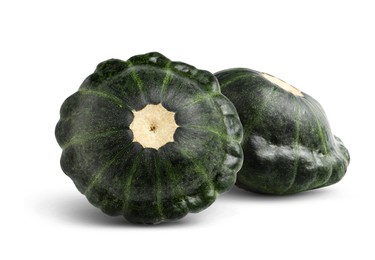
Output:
55,53,243,224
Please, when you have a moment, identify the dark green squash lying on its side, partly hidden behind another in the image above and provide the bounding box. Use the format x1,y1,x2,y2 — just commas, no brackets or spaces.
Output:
215,68,349,194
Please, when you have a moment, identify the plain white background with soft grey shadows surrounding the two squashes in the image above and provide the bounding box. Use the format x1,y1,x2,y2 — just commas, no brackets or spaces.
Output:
0,0,375,260
